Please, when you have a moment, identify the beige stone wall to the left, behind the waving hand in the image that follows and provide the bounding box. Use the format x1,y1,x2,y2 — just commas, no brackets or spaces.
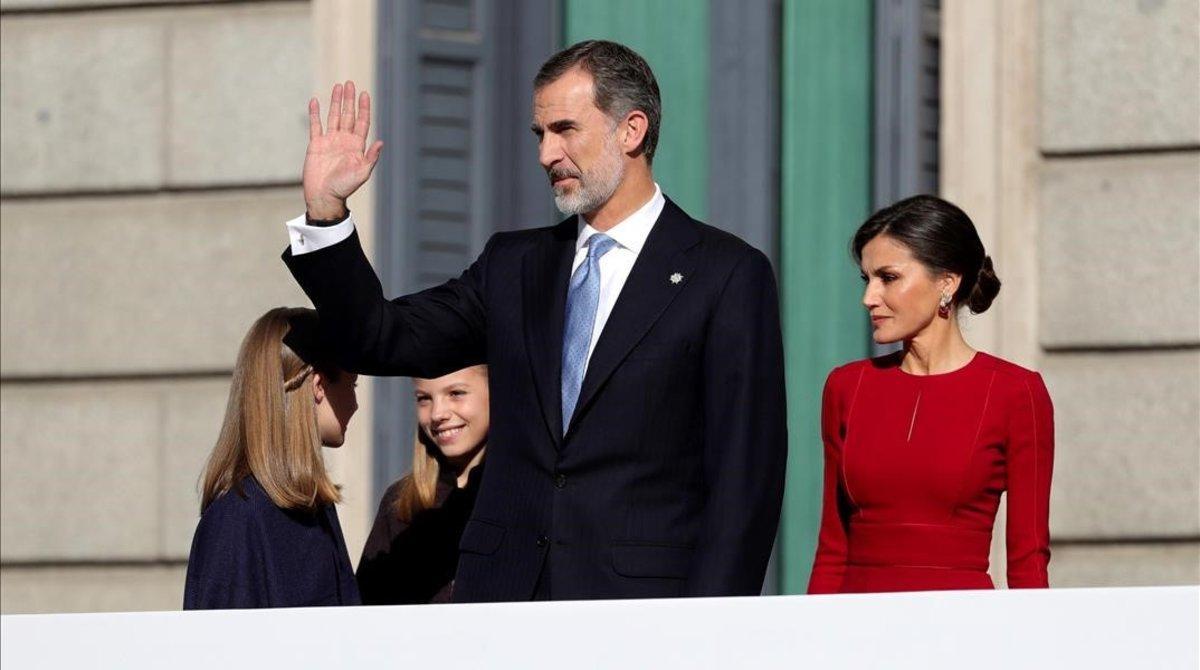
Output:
0,0,374,614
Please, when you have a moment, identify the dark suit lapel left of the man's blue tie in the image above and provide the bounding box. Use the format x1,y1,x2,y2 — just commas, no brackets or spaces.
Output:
521,216,578,444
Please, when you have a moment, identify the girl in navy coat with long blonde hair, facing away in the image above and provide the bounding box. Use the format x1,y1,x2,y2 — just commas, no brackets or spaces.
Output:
184,307,360,610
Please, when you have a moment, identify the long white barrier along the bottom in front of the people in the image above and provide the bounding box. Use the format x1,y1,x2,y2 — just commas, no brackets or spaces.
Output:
0,586,1200,670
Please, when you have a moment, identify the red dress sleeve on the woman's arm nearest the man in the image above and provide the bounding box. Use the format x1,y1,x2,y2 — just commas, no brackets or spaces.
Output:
809,370,850,593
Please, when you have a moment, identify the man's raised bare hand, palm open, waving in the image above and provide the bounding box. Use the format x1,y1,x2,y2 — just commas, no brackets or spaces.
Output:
304,82,383,220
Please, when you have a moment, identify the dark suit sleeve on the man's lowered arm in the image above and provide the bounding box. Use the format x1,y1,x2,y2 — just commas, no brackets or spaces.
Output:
686,250,787,596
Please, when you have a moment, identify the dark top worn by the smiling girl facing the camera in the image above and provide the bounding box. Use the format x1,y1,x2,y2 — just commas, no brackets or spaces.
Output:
358,463,484,605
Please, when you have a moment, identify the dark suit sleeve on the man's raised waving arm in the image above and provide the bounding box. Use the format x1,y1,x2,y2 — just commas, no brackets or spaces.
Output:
283,233,492,377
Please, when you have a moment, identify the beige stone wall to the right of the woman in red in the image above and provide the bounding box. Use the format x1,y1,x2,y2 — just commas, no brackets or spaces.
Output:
942,0,1200,586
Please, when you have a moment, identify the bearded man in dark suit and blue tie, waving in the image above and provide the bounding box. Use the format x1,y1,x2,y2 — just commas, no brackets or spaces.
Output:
284,42,787,602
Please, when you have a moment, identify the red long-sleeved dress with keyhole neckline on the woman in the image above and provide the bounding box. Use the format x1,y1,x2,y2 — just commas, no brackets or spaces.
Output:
809,352,1054,593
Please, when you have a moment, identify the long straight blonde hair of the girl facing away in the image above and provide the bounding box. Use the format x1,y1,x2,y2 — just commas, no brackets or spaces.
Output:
200,307,341,513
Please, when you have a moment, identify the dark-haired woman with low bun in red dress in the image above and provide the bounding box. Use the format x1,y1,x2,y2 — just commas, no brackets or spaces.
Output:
809,196,1054,593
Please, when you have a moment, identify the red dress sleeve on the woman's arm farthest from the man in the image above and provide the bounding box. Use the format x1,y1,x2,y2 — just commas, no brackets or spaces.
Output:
1007,375,1054,588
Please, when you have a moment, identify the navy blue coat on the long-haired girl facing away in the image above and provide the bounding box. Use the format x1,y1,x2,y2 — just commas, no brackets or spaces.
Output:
184,477,360,610
